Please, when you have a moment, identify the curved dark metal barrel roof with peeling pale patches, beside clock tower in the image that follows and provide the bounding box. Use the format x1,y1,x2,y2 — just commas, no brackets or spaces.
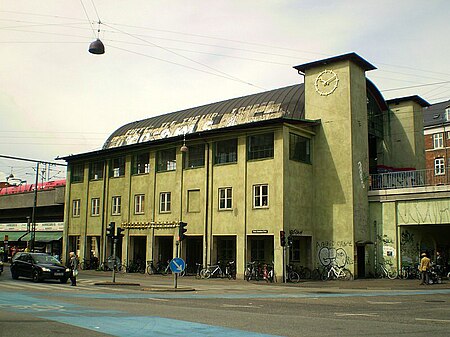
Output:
103,84,305,149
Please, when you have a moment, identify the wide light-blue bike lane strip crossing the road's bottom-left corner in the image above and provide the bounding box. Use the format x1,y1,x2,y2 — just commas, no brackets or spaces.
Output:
0,292,276,337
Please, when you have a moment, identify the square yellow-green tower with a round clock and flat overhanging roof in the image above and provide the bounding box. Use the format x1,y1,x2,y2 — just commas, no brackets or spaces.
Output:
294,53,376,276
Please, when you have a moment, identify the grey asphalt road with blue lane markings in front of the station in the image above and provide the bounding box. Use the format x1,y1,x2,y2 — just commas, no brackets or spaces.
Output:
0,268,450,337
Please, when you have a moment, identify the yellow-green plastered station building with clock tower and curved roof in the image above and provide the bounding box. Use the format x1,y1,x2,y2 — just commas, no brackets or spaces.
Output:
63,53,425,277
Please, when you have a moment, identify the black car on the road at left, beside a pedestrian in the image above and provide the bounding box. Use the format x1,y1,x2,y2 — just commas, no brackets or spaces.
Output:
10,252,70,283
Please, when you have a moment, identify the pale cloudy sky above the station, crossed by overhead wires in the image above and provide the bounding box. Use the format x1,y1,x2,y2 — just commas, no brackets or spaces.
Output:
0,0,450,183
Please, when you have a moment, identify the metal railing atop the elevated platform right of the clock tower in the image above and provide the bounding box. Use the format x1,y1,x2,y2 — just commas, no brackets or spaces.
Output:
370,167,450,190
